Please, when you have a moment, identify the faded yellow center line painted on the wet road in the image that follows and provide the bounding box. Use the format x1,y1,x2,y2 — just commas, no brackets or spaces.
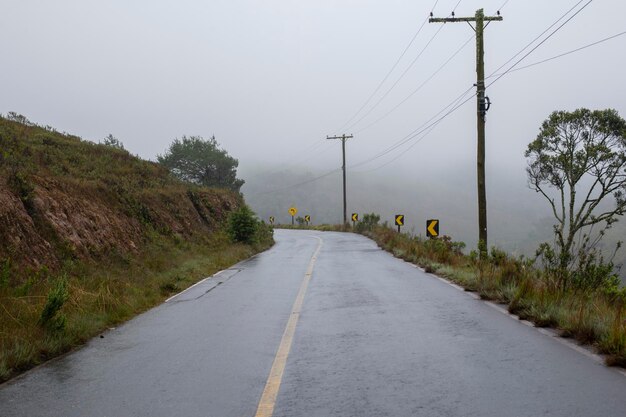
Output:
254,236,323,417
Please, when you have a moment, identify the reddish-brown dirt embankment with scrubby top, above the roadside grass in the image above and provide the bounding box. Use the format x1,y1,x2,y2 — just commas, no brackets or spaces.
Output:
0,119,242,269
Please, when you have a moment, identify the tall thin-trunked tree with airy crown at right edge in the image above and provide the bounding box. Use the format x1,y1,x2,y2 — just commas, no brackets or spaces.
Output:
526,109,626,288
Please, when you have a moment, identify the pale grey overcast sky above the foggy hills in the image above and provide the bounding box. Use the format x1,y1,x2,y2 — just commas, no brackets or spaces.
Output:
0,0,626,195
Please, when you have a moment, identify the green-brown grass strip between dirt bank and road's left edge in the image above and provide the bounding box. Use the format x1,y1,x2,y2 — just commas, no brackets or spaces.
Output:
0,233,271,382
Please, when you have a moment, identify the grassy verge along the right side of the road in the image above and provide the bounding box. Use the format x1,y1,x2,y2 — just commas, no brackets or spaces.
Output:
364,226,626,367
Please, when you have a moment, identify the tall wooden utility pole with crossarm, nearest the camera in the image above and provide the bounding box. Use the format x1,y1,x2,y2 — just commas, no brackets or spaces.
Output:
429,9,502,259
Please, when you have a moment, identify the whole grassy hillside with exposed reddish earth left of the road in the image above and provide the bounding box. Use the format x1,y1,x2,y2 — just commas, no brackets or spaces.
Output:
0,115,271,381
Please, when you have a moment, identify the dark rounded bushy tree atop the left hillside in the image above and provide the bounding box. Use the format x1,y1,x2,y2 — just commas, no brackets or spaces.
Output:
157,136,244,192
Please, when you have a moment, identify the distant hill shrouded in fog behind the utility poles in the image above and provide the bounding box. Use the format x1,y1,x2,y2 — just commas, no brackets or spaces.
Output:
242,161,626,282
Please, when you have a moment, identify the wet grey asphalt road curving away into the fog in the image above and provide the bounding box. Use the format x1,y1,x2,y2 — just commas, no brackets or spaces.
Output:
0,230,626,417
